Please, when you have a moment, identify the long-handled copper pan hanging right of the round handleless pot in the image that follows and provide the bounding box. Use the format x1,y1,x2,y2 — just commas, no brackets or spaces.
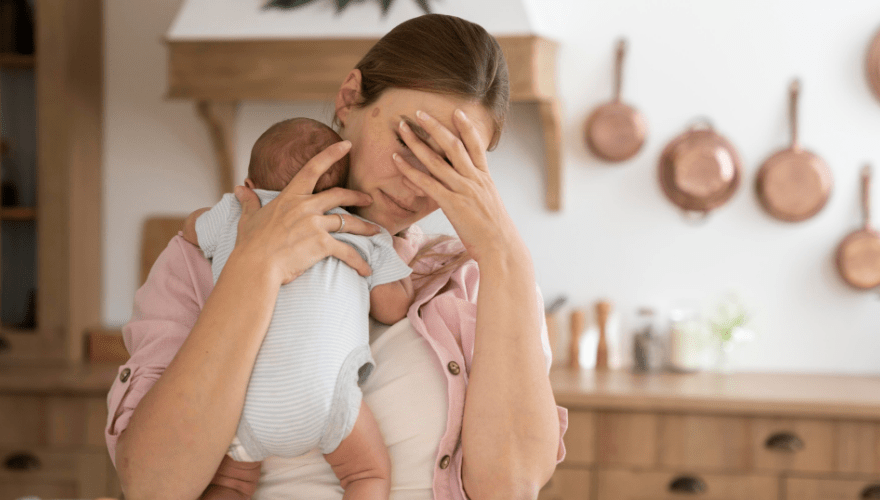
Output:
755,80,833,222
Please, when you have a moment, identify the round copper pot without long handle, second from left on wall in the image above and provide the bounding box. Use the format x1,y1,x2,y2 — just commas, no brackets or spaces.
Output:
658,121,742,216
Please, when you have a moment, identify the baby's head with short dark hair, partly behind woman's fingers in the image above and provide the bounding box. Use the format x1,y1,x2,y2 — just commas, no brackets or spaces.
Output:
248,118,348,193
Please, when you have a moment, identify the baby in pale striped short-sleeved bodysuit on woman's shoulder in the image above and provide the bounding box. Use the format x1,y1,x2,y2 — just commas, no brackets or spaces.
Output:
184,118,414,499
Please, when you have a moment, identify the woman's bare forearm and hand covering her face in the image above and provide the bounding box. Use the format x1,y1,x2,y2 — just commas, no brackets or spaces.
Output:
395,111,559,499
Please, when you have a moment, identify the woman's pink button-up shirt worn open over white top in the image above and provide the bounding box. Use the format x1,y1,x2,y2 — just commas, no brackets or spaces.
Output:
104,227,568,500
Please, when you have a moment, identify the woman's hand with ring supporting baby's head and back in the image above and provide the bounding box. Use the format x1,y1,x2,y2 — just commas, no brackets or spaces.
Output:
227,141,379,285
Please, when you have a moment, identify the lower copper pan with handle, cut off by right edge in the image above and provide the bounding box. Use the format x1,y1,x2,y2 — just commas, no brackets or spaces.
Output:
836,165,880,290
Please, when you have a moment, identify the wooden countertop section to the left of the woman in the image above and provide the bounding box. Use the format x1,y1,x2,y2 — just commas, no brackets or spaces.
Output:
0,360,119,396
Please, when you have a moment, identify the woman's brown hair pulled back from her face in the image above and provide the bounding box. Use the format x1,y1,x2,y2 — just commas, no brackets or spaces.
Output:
334,14,510,150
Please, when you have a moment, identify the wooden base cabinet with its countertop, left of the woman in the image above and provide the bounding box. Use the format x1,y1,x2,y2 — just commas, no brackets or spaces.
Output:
0,362,122,499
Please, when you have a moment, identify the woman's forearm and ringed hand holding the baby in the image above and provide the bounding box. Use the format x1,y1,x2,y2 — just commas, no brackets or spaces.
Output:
115,142,378,500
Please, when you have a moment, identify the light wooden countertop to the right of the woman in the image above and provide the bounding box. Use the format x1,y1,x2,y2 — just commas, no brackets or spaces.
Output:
550,368,880,419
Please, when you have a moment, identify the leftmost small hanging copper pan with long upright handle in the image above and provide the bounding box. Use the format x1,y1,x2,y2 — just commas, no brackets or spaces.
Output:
585,40,646,162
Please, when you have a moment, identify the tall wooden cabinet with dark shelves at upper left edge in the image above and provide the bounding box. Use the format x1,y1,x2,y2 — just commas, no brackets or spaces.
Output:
0,0,103,363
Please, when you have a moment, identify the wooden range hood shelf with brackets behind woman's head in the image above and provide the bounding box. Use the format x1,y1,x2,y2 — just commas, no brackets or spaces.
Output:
168,35,563,211
